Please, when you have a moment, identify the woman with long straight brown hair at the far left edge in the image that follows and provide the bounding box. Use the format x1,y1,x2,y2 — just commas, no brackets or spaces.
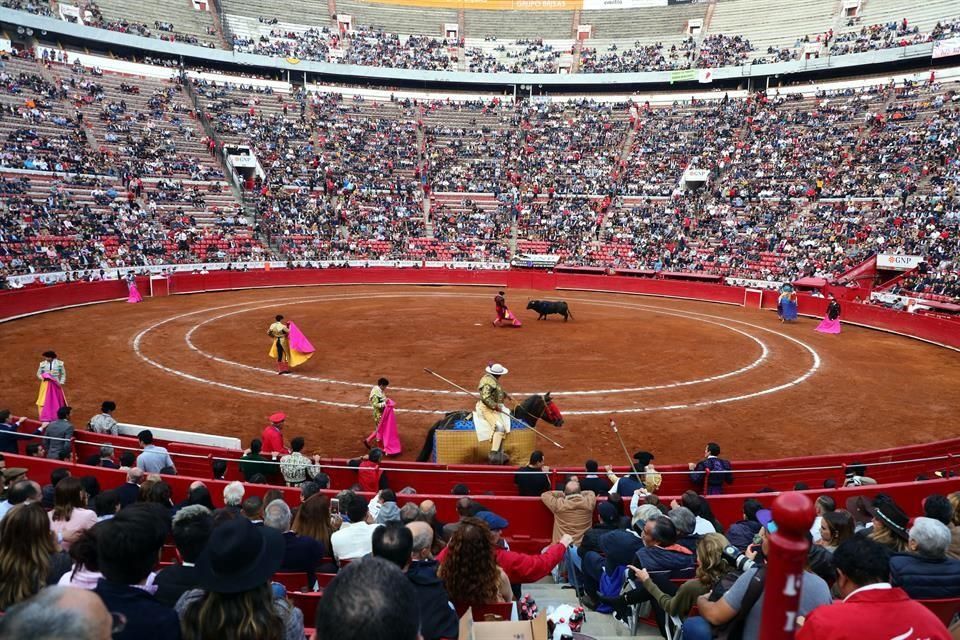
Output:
0,503,70,611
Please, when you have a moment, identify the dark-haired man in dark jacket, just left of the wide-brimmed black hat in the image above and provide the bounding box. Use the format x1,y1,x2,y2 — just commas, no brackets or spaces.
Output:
154,504,213,607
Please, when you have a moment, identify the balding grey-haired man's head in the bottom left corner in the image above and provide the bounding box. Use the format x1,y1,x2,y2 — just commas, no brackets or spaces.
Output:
0,587,113,640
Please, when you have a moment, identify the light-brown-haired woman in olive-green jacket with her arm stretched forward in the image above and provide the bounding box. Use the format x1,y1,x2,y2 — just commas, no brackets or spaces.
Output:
601,533,730,622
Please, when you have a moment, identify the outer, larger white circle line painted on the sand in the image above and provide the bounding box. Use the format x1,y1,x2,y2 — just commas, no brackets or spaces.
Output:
133,294,821,415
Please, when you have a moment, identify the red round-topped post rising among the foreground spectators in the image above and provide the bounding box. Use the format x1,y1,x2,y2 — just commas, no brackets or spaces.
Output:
760,492,815,640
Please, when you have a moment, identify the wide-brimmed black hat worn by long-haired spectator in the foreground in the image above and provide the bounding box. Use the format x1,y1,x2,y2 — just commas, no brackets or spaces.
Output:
197,518,286,593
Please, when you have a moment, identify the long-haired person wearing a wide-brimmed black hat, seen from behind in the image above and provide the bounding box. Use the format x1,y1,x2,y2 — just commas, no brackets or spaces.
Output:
176,518,303,640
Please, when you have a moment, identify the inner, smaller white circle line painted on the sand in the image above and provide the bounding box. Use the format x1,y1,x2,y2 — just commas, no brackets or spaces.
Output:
184,294,770,397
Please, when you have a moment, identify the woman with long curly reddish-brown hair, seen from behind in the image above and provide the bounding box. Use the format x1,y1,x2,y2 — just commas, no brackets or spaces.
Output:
437,517,513,605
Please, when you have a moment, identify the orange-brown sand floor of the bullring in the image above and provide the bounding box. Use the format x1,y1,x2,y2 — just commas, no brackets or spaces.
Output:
0,286,960,464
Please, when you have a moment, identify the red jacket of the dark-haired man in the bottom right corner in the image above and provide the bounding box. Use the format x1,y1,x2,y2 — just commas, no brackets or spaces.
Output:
797,588,950,640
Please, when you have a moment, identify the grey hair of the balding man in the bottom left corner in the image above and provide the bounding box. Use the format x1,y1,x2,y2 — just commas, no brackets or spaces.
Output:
0,586,100,640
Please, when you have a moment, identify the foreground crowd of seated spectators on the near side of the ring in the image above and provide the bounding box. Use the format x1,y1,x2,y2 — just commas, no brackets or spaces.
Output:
0,424,960,640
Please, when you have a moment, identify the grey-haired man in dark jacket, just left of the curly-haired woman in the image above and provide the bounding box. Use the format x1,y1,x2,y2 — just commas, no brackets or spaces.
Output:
405,521,460,640
